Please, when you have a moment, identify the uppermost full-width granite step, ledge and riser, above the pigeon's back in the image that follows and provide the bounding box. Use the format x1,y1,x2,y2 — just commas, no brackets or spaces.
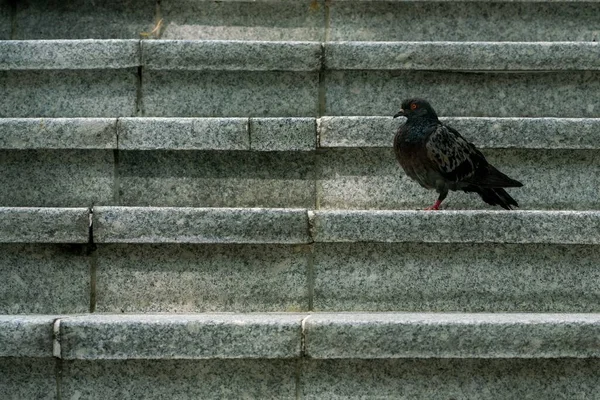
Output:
0,40,600,118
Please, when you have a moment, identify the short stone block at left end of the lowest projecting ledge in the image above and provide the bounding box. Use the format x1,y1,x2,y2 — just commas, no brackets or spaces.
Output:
0,315,54,357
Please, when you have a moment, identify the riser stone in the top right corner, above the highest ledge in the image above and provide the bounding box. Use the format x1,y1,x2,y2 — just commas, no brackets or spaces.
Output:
329,1,600,42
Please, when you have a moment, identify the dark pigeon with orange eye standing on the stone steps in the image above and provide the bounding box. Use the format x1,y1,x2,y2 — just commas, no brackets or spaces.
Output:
394,99,523,210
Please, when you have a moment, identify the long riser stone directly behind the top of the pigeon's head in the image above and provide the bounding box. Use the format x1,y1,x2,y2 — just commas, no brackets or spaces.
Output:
324,70,600,118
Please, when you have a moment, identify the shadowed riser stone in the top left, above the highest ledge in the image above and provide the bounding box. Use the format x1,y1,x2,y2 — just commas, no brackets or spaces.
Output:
14,0,156,39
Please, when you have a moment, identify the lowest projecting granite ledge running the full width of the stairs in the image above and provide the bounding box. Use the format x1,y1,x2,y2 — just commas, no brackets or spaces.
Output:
0,313,600,360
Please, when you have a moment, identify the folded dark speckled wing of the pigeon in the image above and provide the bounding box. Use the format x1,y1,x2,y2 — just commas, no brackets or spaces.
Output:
425,124,488,183
